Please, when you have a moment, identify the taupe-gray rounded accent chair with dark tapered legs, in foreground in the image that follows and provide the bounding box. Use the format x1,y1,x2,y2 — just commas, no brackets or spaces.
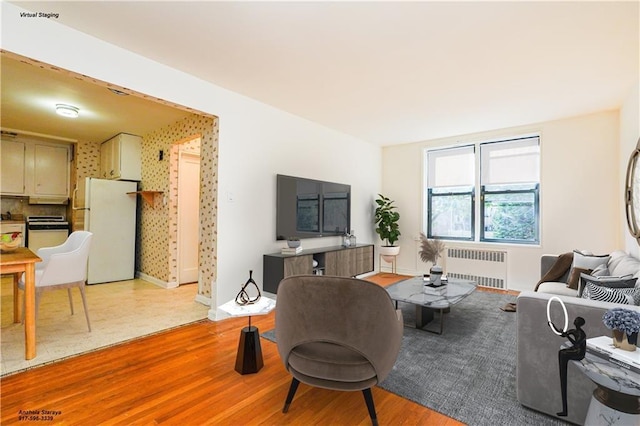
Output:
276,275,403,425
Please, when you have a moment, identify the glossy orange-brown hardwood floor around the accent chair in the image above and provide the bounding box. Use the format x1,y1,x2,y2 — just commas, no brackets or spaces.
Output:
0,274,476,426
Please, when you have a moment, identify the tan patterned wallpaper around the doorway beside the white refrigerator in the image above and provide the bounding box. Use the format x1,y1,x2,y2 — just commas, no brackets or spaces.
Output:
136,114,218,298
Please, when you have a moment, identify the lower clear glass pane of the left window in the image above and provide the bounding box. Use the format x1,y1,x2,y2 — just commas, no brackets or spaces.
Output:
429,193,473,239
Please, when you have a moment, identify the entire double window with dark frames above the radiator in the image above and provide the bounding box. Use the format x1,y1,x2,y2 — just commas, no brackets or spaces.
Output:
426,136,540,244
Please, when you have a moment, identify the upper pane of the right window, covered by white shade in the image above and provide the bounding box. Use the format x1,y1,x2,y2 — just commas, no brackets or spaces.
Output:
480,137,540,185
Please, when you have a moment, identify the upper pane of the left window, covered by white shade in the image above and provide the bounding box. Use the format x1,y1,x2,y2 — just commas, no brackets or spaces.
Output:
427,146,475,188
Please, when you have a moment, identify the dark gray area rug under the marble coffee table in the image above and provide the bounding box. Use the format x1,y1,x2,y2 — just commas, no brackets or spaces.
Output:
262,291,569,426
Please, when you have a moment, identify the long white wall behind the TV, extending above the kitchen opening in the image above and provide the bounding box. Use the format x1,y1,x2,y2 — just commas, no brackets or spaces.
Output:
1,2,381,317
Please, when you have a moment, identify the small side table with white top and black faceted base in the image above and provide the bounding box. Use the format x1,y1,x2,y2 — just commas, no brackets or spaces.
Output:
218,296,276,374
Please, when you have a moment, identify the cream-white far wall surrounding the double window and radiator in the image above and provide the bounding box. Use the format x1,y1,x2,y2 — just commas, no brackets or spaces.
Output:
382,111,622,290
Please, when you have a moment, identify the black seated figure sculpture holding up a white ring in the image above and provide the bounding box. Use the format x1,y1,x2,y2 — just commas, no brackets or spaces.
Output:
547,296,587,417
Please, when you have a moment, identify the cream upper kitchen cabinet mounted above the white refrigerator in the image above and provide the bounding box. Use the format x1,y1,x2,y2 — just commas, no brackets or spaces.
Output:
100,133,142,181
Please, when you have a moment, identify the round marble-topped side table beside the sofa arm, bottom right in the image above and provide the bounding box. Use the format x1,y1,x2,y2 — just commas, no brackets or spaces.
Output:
572,352,640,426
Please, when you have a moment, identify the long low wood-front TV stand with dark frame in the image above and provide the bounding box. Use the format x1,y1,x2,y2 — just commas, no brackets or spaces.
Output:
262,244,374,293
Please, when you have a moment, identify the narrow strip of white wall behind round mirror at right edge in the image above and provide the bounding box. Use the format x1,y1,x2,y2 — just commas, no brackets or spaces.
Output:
619,83,640,257
